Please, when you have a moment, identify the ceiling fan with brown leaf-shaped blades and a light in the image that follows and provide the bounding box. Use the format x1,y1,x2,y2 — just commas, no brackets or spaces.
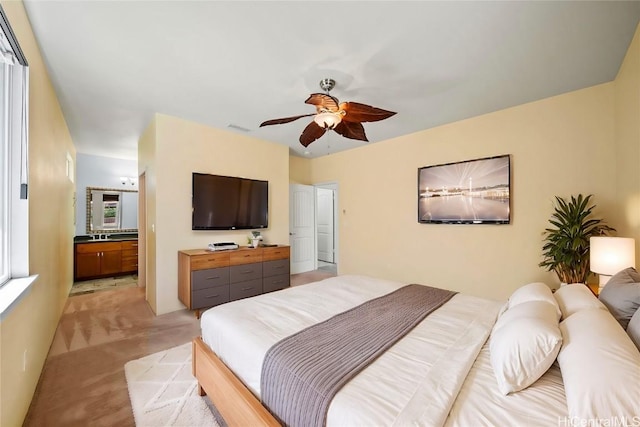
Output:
260,79,396,147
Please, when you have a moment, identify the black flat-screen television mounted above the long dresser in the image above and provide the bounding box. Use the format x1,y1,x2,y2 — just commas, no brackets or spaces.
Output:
191,172,269,230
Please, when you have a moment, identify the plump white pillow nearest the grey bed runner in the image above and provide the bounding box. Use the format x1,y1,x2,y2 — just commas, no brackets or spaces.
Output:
489,300,562,395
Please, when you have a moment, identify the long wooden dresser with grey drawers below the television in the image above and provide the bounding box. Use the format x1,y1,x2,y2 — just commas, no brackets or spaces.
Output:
178,246,290,316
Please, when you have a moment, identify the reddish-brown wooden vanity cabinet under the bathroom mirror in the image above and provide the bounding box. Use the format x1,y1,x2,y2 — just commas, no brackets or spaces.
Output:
74,239,138,281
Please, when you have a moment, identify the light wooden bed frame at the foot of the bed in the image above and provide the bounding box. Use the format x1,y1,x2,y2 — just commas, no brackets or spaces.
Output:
192,337,280,427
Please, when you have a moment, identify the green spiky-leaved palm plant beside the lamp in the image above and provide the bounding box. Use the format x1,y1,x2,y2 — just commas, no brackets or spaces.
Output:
539,194,615,283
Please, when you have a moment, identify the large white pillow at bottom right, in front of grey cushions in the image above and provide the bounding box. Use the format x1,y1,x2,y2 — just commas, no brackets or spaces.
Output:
558,308,640,425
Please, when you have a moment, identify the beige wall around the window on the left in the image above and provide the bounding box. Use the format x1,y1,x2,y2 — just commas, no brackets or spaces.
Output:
0,1,75,427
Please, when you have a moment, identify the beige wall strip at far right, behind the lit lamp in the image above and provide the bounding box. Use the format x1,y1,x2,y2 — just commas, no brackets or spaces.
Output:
612,25,640,267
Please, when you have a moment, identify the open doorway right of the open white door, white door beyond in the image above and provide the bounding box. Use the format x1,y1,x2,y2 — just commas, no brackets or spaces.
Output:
315,183,338,274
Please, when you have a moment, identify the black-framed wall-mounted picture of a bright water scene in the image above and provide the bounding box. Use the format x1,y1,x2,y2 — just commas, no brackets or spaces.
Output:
418,155,511,224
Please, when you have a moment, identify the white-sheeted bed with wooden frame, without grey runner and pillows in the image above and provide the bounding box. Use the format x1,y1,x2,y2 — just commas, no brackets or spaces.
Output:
193,276,640,426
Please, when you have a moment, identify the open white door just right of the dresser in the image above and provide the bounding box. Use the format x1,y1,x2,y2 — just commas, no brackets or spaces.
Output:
289,184,316,274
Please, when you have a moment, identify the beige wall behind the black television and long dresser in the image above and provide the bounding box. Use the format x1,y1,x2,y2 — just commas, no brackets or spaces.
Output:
138,114,289,314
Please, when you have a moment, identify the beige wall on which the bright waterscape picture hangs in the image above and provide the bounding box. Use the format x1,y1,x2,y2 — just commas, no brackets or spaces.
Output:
310,83,618,299
